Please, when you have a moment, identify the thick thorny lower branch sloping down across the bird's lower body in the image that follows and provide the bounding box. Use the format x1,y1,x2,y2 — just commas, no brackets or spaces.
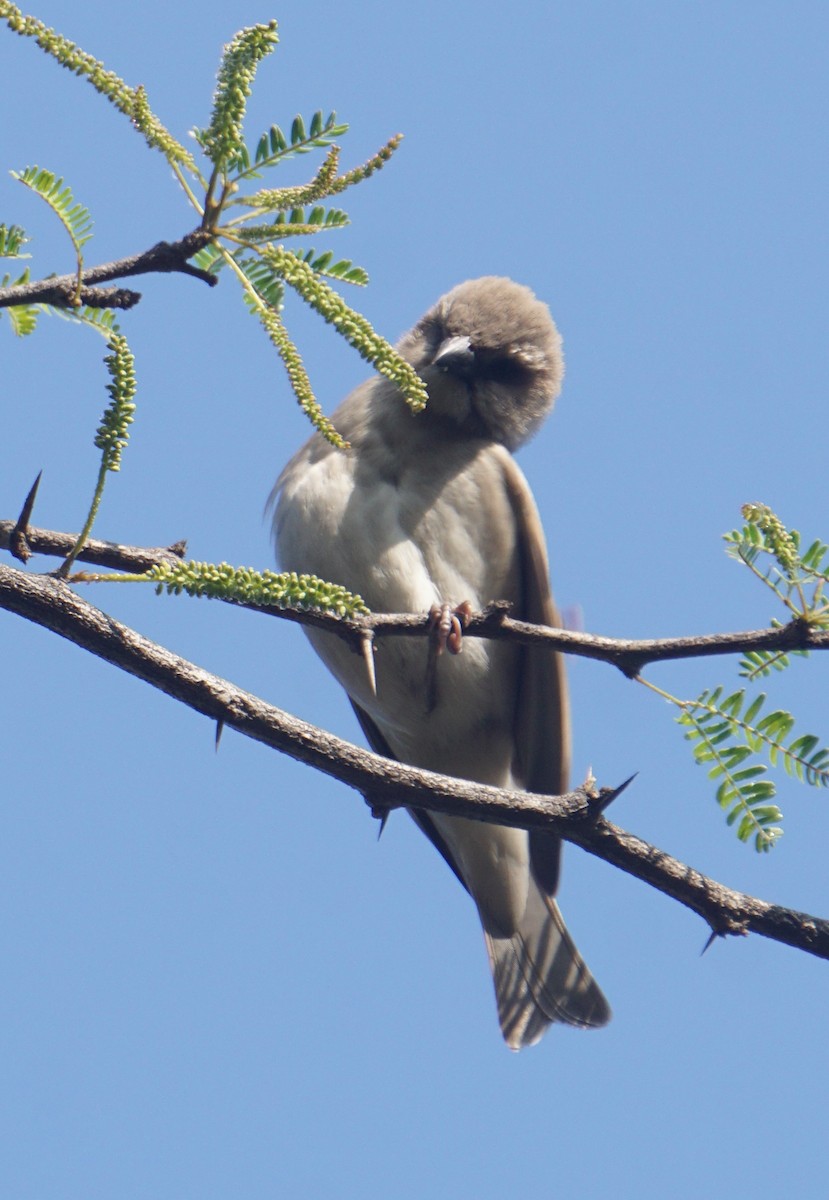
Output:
0,556,829,959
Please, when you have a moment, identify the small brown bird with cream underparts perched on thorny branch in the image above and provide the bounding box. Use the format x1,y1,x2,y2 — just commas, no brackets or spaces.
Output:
270,276,611,1050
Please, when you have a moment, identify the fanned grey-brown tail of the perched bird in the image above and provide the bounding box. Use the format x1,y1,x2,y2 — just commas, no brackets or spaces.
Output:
483,881,611,1050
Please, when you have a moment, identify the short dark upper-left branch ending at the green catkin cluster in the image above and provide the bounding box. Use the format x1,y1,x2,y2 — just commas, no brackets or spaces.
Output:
0,229,218,308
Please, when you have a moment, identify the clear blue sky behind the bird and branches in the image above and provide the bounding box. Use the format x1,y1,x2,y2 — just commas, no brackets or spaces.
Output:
0,0,829,1200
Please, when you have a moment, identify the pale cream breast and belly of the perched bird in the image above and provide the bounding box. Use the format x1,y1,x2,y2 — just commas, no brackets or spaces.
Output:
276,432,519,785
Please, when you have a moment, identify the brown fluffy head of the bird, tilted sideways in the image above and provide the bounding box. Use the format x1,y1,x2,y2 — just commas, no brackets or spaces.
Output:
397,275,564,450
